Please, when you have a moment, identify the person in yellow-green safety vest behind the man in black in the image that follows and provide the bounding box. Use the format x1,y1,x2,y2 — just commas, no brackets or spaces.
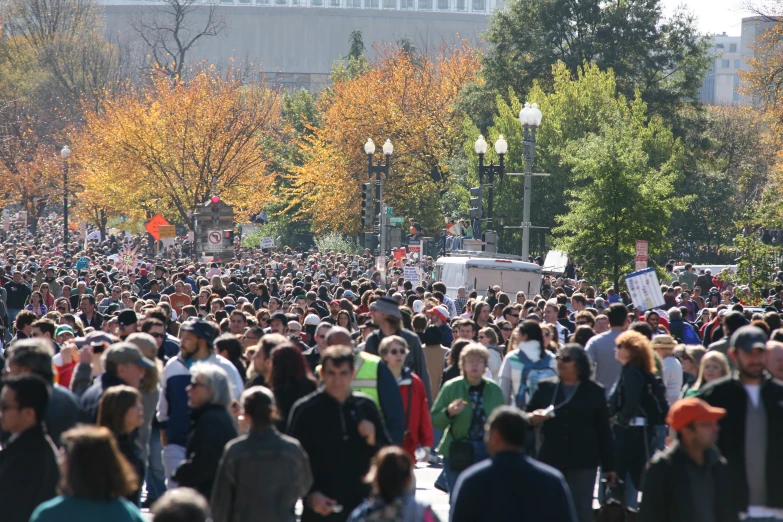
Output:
316,326,405,446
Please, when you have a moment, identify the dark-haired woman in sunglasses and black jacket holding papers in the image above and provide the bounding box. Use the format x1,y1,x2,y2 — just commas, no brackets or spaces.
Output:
526,343,616,522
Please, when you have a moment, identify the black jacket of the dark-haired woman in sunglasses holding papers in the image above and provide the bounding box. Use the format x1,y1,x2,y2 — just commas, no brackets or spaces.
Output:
527,377,614,471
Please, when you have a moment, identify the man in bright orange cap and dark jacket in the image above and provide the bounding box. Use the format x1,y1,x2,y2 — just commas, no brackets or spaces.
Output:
639,398,739,522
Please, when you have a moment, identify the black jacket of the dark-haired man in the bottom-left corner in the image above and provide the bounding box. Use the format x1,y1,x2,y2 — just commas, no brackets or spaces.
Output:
0,425,60,522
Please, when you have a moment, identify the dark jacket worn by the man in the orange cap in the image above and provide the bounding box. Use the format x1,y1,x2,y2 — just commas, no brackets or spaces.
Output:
639,442,739,522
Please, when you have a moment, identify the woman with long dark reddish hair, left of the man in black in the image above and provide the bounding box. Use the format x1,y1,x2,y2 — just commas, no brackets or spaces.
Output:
270,343,318,431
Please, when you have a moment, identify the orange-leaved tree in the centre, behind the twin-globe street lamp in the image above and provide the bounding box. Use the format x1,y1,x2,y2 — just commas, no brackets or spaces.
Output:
291,42,480,233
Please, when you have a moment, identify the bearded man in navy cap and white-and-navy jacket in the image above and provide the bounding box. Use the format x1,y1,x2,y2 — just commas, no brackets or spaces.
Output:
158,319,244,489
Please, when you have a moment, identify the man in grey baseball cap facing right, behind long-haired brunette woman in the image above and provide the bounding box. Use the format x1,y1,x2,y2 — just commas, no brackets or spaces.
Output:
81,342,155,424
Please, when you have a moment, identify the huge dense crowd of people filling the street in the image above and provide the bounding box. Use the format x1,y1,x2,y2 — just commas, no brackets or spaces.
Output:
0,217,783,522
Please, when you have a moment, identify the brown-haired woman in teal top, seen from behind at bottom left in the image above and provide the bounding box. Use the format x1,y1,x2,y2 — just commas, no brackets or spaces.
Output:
30,426,144,522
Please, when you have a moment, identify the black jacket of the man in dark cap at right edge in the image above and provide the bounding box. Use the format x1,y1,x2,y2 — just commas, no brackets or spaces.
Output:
700,373,783,512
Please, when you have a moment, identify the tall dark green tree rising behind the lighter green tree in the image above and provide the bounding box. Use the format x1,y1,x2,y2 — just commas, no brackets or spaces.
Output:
484,0,710,132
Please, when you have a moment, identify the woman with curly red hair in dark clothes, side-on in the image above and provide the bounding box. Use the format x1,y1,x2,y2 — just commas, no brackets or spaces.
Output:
609,331,665,496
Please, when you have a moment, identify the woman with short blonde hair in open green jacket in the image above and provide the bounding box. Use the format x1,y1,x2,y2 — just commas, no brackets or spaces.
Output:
431,343,505,493
